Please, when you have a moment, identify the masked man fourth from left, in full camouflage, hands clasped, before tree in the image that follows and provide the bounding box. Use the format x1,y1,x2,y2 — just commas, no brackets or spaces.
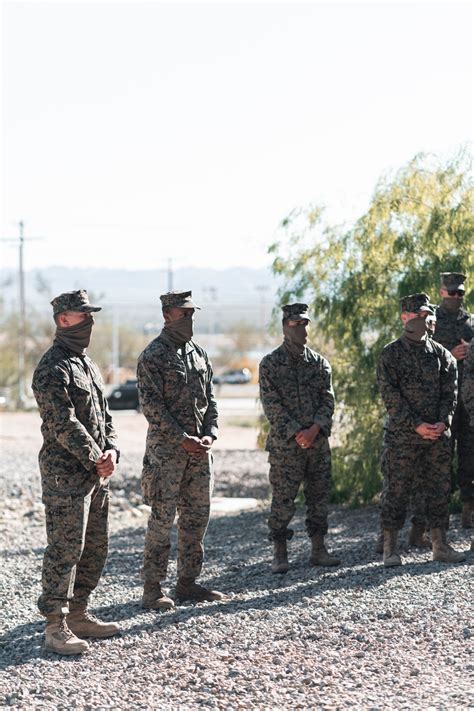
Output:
377,294,464,566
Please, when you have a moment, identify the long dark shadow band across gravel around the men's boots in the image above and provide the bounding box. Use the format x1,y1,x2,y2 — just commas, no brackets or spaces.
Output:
0,508,474,669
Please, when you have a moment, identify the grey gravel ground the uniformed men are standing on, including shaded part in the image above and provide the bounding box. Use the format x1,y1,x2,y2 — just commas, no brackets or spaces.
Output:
0,437,474,711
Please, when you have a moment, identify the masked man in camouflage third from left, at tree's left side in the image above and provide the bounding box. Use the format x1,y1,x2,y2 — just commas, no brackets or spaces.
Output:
259,304,339,573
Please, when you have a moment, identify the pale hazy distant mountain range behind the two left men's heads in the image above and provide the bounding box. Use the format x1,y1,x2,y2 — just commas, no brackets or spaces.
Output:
0,266,280,331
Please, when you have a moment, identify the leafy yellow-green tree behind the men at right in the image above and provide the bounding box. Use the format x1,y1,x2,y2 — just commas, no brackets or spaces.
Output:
270,152,474,504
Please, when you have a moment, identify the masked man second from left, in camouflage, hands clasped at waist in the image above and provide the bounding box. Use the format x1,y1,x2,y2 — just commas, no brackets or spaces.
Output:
137,291,223,610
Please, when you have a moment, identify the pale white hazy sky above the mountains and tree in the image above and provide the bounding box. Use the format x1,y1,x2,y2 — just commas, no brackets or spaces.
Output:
0,0,473,268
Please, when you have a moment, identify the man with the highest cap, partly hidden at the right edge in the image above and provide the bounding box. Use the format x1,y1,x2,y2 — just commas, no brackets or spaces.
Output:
434,272,474,528
